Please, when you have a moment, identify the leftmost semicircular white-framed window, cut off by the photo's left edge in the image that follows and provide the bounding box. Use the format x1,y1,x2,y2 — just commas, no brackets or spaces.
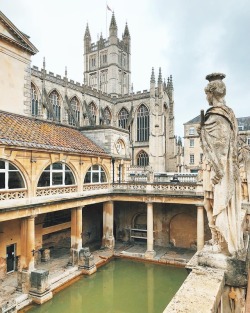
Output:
0,160,25,189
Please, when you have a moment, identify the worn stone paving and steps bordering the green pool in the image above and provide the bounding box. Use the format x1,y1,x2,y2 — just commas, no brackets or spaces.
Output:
0,243,195,312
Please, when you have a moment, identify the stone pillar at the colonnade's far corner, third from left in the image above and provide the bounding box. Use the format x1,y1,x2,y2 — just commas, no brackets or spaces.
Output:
102,201,115,249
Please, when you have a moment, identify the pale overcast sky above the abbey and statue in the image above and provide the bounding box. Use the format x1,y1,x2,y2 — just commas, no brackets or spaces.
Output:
0,0,250,136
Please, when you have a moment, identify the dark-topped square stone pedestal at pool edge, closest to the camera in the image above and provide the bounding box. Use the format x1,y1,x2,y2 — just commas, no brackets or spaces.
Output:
30,270,53,304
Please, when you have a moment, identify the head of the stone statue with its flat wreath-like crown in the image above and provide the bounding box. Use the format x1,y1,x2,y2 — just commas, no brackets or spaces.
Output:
205,73,226,105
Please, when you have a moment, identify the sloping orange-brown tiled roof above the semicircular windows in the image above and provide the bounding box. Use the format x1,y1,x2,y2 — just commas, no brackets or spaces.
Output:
0,111,108,156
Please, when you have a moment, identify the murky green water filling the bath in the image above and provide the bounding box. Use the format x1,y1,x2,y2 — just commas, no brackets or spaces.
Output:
29,259,187,313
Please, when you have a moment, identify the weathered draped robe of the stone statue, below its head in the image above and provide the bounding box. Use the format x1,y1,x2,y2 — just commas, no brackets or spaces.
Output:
201,105,243,254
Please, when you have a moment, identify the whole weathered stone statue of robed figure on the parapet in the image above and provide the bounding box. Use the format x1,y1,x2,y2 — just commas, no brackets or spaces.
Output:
197,73,243,256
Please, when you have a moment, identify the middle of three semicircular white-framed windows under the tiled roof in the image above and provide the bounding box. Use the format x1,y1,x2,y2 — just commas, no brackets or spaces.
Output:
38,162,75,187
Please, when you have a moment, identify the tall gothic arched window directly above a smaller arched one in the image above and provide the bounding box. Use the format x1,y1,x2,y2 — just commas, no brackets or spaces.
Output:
137,104,149,141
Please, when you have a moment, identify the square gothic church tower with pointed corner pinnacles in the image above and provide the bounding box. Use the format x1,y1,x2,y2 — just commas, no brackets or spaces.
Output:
84,13,131,97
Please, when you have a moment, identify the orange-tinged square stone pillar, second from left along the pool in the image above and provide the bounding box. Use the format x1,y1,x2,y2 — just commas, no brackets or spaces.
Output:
71,207,82,250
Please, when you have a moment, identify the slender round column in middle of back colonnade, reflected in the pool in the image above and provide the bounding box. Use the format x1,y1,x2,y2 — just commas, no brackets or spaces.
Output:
145,202,155,259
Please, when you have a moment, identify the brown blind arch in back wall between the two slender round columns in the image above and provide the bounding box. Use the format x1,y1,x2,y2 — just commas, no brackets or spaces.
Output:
169,213,197,248
